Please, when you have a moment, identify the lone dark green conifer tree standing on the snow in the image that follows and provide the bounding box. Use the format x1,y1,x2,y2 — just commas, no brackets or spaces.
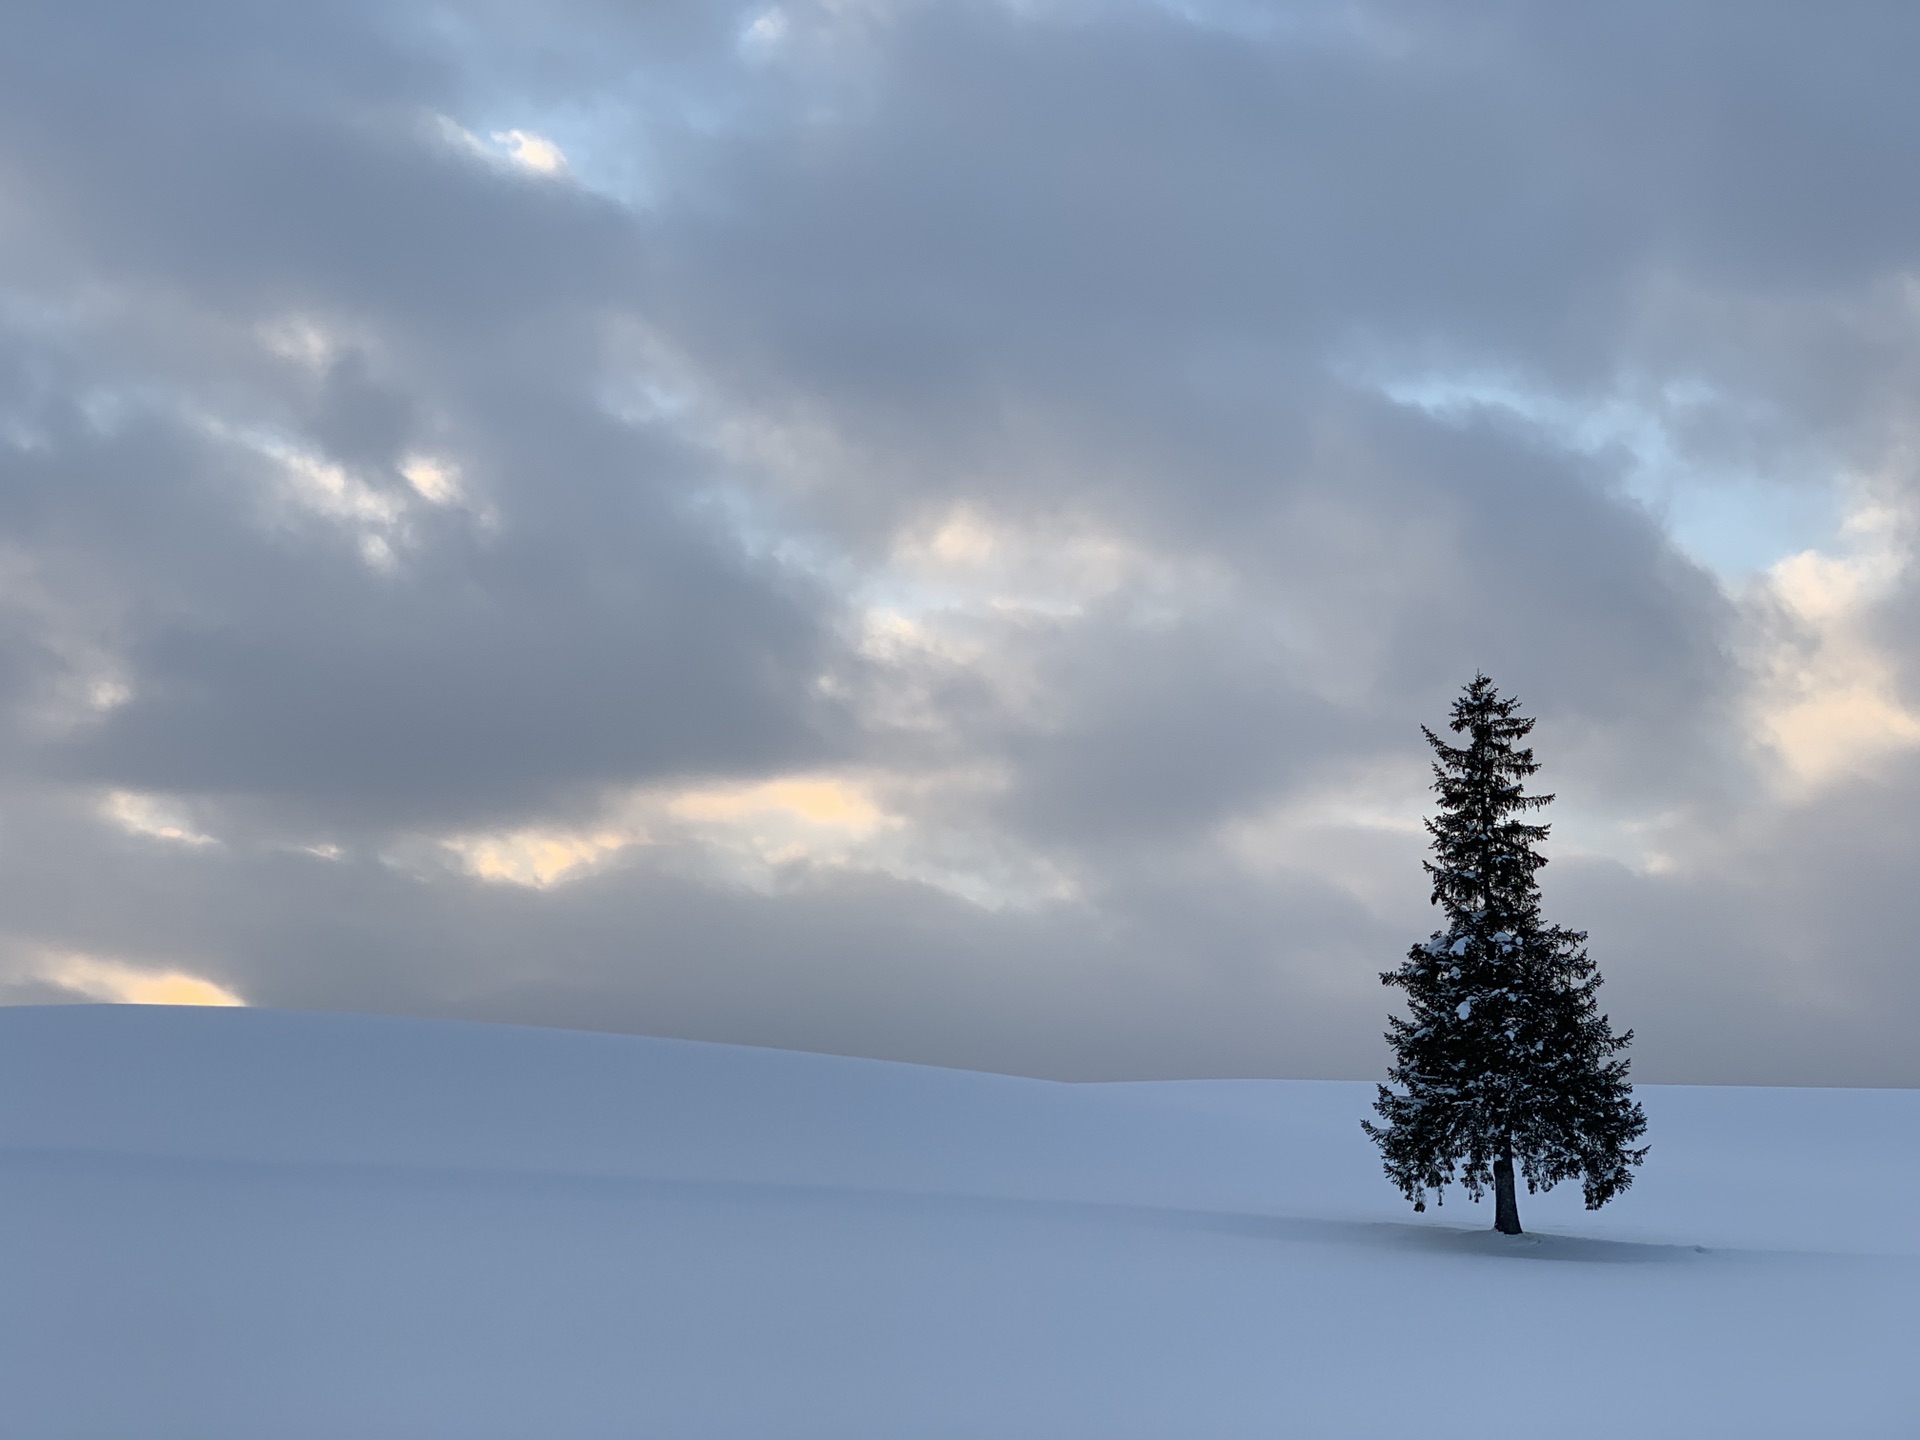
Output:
1361,674,1647,1235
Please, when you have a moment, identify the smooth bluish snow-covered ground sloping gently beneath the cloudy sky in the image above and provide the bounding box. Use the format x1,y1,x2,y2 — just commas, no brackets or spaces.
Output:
0,1006,1920,1440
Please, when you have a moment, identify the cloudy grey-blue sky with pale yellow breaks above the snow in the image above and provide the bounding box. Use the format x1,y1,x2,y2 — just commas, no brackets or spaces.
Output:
0,0,1920,1085
